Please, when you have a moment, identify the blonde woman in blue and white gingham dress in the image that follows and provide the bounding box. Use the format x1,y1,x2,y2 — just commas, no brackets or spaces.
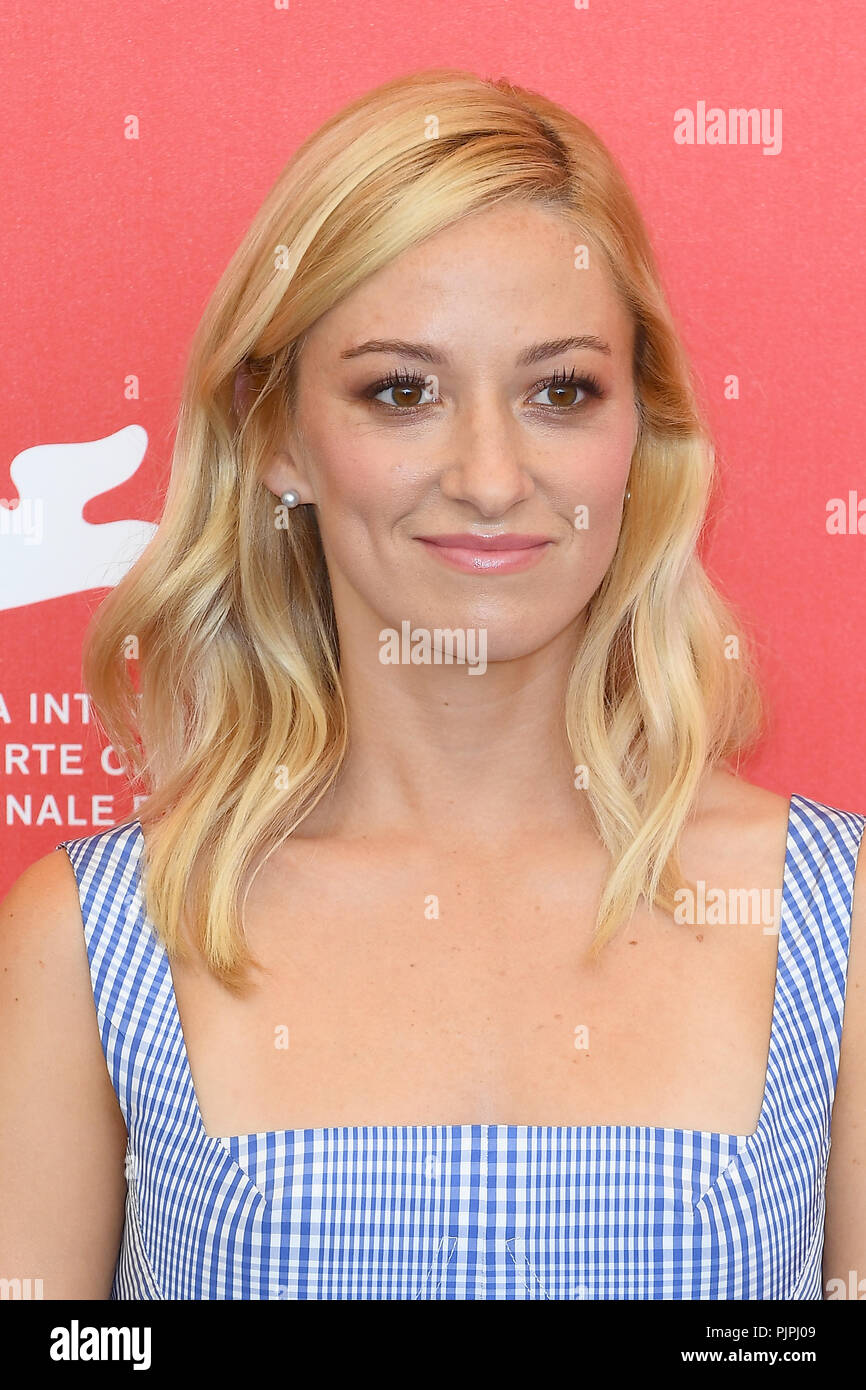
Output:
1,71,866,1298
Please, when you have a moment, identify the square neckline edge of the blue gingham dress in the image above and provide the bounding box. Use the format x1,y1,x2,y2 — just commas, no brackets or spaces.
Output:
159,792,801,1150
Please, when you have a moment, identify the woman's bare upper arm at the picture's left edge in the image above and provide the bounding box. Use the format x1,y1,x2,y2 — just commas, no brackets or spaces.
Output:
0,849,126,1298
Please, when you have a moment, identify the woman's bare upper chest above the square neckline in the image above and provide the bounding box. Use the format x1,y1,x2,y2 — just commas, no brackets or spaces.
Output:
172,834,777,1136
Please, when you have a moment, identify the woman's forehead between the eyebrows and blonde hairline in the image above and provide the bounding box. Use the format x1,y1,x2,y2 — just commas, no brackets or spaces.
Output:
306,202,634,361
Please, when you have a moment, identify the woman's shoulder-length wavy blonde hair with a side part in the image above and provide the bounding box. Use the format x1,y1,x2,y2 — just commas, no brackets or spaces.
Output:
77,70,763,991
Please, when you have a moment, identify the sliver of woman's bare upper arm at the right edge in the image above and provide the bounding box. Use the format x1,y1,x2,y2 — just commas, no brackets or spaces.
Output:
823,834,866,1298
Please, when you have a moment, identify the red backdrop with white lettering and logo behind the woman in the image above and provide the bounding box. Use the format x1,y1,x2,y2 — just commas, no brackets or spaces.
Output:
0,0,866,892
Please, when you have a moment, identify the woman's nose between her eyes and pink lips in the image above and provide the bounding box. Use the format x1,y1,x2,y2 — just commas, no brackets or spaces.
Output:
439,392,535,517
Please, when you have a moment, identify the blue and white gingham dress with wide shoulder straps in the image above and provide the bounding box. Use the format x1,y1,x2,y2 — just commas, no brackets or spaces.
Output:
63,795,866,1300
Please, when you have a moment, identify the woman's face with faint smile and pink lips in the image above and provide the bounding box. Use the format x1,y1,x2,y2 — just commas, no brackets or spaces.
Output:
265,203,637,662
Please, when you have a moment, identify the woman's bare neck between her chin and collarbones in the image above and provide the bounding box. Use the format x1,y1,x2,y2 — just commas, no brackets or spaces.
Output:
302,603,589,847
